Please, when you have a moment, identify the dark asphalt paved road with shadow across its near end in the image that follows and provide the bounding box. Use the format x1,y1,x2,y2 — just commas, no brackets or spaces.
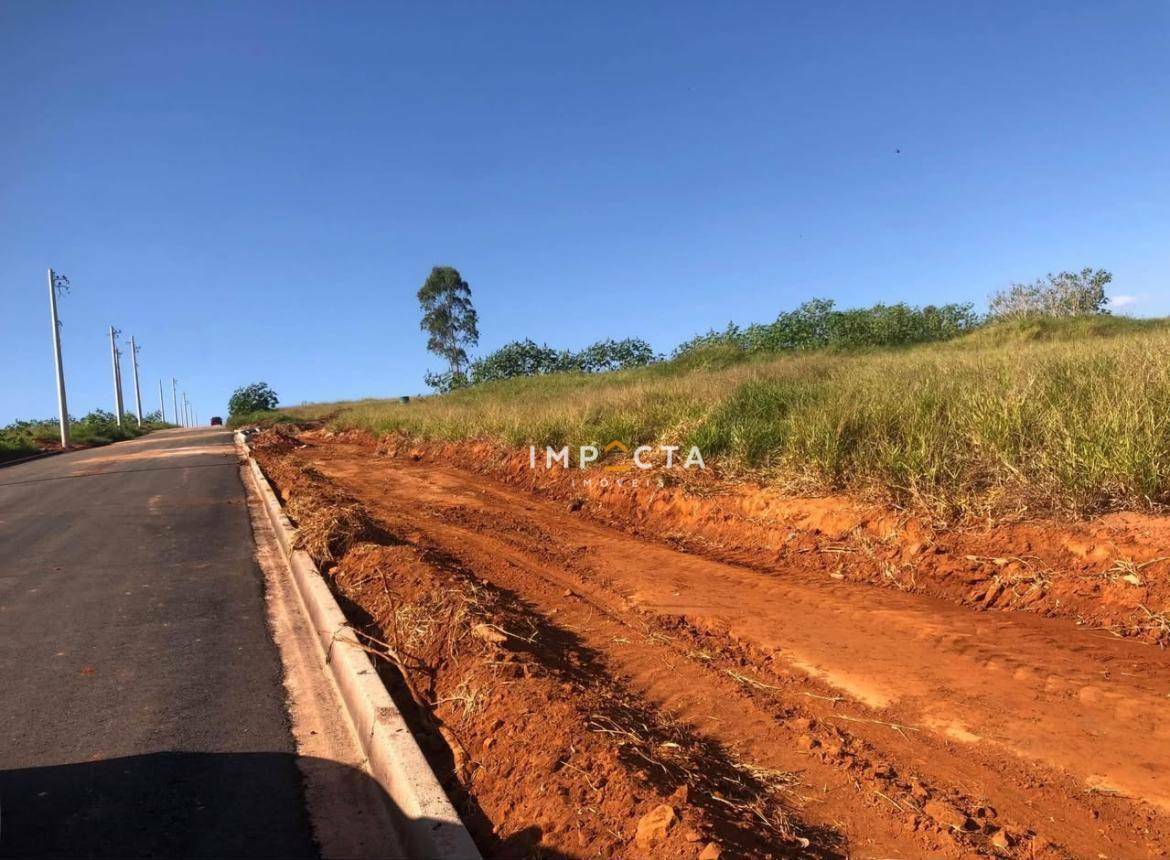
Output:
0,429,316,858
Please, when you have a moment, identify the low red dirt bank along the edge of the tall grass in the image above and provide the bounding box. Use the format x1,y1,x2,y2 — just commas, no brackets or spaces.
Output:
367,434,1170,645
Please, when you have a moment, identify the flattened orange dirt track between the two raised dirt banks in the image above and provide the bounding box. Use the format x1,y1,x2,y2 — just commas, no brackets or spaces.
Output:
269,443,1170,856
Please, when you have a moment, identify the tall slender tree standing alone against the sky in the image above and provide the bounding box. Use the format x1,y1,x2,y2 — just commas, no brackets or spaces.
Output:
419,266,480,391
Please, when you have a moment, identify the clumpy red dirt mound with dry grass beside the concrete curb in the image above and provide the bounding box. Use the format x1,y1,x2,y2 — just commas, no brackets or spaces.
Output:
256,442,820,858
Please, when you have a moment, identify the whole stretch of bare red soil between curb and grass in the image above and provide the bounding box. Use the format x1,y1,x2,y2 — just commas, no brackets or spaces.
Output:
257,432,1170,858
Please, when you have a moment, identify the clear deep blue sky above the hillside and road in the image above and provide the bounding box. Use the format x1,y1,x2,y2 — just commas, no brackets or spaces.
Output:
0,0,1170,422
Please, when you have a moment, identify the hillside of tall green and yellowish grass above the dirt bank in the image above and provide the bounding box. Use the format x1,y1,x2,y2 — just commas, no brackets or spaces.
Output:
287,317,1170,514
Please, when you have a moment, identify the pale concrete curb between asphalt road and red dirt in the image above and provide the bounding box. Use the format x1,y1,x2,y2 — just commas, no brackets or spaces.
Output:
235,431,481,860
